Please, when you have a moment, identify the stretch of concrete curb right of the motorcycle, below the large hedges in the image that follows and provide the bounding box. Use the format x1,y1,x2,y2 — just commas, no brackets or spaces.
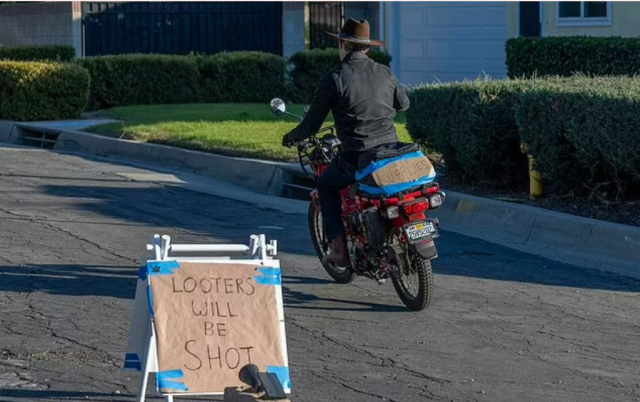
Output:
432,192,640,279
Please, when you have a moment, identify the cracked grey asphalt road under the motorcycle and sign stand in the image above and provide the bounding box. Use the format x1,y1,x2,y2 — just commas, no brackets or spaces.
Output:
0,147,640,402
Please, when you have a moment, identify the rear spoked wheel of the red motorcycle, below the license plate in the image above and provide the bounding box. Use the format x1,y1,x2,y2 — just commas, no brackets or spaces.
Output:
392,231,433,311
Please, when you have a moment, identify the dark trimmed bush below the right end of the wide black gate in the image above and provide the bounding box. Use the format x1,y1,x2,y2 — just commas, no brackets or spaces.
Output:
198,52,287,102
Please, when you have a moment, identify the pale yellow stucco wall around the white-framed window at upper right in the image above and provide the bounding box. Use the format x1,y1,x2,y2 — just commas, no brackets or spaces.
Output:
542,1,640,36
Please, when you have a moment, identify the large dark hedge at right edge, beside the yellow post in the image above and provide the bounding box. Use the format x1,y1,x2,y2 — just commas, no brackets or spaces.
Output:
516,77,640,198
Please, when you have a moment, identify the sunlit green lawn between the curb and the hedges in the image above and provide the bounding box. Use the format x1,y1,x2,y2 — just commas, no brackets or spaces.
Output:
90,103,411,161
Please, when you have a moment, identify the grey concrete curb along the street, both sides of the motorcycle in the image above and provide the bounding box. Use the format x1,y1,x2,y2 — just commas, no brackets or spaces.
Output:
0,121,640,279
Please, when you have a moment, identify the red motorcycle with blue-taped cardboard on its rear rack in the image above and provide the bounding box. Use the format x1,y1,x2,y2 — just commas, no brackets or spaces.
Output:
271,98,445,311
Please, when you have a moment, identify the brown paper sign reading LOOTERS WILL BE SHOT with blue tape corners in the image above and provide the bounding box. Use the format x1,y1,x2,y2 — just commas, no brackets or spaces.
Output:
147,261,291,394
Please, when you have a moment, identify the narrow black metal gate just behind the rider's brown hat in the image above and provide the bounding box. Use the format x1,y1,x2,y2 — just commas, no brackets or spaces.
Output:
309,1,344,49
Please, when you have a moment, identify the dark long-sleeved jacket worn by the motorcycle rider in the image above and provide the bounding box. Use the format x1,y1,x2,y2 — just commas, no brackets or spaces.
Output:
288,52,409,152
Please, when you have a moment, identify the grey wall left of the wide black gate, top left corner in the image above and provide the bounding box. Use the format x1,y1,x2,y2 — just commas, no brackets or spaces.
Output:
0,1,82,56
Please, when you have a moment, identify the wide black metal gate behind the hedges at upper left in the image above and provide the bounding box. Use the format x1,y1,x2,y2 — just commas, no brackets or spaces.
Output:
82,1,282,56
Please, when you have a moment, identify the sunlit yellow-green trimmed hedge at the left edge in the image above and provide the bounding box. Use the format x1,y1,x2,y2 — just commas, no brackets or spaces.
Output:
0,61,89,120
